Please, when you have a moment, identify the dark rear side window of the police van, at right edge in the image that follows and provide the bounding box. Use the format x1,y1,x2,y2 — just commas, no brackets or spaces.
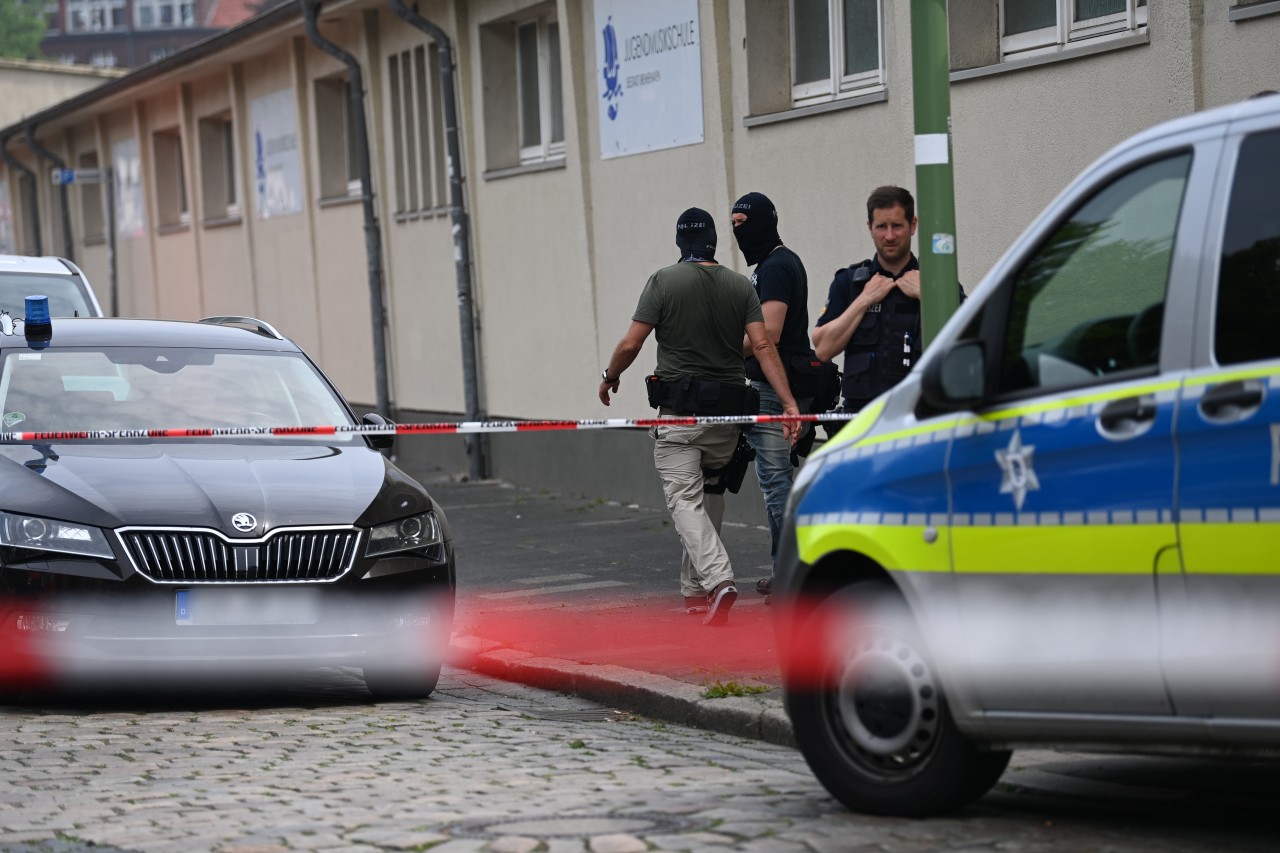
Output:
1213,131,1280,364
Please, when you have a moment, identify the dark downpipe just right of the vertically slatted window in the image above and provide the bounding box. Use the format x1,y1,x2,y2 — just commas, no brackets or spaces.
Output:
388,0,485,480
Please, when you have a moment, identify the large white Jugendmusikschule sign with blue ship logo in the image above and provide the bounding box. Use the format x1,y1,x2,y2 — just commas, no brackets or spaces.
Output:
595,0,703,159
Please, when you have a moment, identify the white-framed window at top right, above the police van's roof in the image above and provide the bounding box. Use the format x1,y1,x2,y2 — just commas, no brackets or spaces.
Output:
1000,0,1147,59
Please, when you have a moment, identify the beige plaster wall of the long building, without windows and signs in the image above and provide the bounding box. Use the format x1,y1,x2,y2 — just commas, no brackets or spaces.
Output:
0,0,1280,520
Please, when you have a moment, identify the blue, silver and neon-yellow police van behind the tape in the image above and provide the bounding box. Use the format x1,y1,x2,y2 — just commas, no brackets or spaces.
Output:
774,95,1280,815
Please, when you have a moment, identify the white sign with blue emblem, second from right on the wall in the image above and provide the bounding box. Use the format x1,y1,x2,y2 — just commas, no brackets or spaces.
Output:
250,88,302,219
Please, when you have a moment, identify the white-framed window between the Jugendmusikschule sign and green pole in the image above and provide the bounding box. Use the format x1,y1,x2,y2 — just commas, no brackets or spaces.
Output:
791,0,884,106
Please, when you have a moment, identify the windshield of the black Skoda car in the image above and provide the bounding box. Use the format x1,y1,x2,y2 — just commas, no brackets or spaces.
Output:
0,347,360,443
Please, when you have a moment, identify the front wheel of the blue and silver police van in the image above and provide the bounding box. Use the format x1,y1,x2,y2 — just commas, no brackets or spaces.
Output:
786,583,1010,816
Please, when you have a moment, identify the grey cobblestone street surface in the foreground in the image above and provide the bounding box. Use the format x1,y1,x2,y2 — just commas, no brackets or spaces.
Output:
0,670,1280,853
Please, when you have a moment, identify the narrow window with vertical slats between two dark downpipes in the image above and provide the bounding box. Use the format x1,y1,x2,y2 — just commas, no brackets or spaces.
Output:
387,44,448,214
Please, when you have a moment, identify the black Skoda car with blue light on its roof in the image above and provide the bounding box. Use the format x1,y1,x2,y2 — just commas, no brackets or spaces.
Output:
0,316,454,697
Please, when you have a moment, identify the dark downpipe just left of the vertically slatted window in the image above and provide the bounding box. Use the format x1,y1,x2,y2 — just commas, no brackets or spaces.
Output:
302,0,392,418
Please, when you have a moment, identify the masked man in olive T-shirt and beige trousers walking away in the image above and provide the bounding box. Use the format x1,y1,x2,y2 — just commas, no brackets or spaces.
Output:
600,207,800,625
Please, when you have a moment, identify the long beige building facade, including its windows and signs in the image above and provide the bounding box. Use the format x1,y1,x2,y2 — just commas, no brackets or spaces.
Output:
0,0,1280,512
